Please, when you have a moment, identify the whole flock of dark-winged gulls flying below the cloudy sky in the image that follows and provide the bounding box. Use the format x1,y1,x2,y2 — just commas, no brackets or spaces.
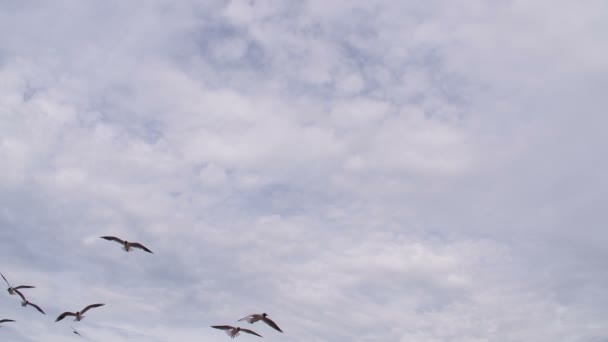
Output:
0,236,283,338
